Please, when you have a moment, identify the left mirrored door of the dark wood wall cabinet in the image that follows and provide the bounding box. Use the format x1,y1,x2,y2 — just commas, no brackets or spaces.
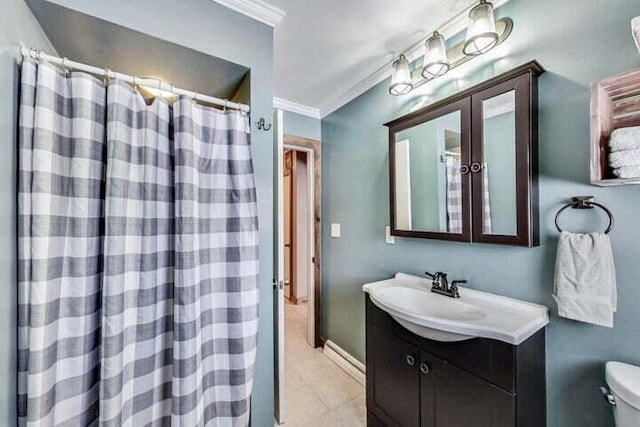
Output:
389,98,471,241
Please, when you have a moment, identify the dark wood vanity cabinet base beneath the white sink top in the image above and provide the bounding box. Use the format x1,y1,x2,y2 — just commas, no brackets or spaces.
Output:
366,296,546,427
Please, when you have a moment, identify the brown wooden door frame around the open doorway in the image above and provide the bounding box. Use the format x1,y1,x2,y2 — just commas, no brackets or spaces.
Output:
279,134,324,347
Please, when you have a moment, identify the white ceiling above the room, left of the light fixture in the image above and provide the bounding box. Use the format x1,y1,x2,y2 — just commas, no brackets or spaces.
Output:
268,0,476,115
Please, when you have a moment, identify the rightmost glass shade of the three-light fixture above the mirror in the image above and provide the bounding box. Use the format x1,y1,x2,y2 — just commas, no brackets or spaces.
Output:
462,0,500,56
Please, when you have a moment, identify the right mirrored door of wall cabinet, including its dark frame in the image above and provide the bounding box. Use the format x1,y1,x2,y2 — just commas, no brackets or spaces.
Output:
470,72,538,247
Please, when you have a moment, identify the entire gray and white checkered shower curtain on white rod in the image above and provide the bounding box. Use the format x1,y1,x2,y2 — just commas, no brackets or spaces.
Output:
18,61,258,427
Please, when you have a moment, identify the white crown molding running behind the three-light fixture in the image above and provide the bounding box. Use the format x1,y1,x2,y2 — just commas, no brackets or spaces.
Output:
320,0,509,118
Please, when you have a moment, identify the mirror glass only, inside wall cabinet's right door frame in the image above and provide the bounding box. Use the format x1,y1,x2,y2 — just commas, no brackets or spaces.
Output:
482,90,518,235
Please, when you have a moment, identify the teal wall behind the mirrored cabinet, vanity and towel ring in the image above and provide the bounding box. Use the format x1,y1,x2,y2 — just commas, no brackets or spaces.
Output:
322,0,640,427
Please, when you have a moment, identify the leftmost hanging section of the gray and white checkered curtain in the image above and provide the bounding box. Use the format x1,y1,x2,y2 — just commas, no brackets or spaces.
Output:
18,61,106,426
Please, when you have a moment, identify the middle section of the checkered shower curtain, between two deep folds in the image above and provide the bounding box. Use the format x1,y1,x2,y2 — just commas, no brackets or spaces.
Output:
99,81,175,427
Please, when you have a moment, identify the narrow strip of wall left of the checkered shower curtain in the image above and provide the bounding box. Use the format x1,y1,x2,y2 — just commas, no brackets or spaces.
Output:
0,0,55,426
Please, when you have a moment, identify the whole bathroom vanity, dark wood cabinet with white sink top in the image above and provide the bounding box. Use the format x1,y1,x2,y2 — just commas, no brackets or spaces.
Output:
363,273,549,427
